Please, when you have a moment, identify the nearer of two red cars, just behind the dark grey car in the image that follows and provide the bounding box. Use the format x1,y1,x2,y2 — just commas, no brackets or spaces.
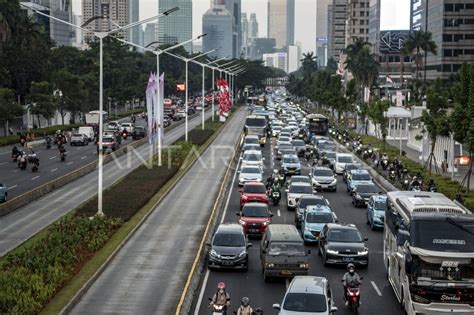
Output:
236,202,273,236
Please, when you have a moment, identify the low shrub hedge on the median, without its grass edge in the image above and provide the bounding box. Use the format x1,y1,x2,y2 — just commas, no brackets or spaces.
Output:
0,116,221,314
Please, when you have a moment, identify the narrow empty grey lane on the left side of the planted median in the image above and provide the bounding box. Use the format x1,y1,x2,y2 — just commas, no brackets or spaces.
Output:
0,112,211,256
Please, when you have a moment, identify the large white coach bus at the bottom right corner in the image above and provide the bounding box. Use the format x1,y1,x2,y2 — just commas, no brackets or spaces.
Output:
383,191,474,315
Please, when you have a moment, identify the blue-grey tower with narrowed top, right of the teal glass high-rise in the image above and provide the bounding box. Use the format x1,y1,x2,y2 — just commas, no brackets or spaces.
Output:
202,0,235,58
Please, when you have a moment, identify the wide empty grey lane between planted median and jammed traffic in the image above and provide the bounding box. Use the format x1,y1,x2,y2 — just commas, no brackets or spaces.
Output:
71,110,246,314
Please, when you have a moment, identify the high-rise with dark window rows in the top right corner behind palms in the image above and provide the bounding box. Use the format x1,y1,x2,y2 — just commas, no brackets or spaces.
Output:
410,0,474,80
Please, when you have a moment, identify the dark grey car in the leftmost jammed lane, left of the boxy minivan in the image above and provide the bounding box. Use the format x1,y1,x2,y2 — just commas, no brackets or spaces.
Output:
207,223,252,270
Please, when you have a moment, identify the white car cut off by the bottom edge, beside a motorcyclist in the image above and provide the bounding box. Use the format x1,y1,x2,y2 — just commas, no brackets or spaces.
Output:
272,276,337,315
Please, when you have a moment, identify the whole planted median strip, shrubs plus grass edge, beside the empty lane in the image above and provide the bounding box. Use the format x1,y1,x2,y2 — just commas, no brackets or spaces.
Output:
0,116,231,314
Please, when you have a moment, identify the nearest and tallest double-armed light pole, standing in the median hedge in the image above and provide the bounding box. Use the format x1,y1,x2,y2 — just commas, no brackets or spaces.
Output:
20,2,179,216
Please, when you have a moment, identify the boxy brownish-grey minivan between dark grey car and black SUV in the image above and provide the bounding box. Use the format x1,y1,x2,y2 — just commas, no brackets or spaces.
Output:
260,224,310,281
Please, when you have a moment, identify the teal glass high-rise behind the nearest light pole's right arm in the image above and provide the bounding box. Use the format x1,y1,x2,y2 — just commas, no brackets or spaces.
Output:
158,0,193,52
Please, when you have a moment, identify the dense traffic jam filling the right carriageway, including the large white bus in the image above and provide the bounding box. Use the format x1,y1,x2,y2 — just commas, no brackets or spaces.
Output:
195,89,474,314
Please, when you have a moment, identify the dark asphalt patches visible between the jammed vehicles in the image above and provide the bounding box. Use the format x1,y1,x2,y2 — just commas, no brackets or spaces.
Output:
194,137,403,315
